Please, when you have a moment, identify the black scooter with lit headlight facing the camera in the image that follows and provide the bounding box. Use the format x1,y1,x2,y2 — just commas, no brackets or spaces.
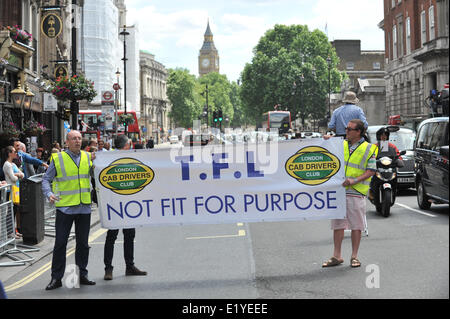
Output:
369,151,406,217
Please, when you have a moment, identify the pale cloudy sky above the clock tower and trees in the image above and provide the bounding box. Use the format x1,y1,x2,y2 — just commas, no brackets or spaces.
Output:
125,0,384,81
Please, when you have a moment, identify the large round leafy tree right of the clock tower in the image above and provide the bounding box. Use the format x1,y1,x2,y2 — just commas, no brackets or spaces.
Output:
240,25,344,129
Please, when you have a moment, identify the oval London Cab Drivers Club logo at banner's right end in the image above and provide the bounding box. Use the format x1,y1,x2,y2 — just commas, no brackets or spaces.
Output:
285,146,341,186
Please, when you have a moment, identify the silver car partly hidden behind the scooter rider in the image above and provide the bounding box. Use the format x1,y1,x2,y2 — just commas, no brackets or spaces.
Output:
367,125,416,189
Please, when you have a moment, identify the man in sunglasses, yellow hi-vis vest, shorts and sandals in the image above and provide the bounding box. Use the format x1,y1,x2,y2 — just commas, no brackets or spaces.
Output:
322,119,378,267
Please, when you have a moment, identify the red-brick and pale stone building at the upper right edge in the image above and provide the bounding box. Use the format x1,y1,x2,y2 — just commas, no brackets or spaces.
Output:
378,0,449,127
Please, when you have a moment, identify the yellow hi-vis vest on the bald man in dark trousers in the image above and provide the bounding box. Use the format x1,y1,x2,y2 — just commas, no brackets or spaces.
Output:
52,151,92,207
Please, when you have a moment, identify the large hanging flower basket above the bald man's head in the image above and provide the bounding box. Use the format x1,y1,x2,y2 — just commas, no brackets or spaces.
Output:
51,75,97,102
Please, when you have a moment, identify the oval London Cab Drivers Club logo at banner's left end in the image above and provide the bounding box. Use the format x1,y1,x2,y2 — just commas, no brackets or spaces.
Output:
99,158,155,195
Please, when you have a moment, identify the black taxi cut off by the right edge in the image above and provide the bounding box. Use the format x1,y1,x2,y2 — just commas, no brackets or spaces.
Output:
414,117,449,209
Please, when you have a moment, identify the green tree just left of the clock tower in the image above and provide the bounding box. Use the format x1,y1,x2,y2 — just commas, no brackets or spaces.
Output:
167,68,201,127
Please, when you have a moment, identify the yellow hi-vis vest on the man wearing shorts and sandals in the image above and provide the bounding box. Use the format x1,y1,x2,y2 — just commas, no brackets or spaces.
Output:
344,140,378,196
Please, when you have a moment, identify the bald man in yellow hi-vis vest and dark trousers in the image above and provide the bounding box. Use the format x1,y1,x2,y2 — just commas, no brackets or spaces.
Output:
42,130,95,290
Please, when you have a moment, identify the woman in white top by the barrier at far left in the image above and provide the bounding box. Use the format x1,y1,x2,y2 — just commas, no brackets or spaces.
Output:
2,146,25,239
